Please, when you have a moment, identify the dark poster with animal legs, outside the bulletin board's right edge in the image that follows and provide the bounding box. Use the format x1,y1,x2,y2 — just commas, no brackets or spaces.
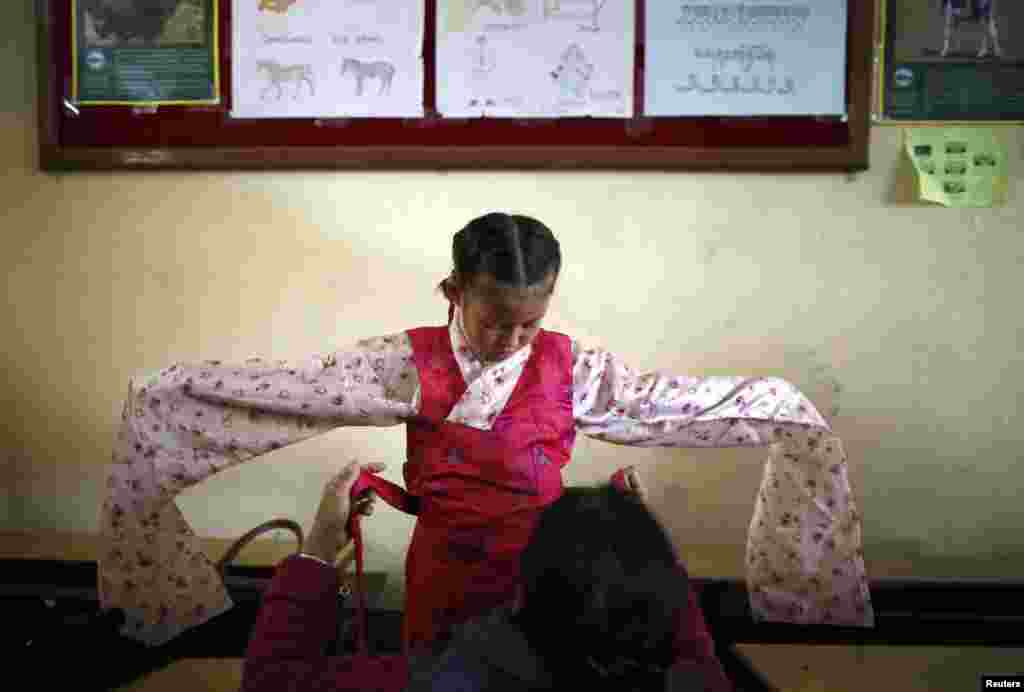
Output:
879,0,1024,123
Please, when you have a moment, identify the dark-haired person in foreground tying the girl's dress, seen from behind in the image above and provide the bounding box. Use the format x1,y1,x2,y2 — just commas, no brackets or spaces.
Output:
242,462,732,692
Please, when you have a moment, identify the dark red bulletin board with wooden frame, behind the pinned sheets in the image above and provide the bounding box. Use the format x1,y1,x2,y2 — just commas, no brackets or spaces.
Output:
37,0,876,171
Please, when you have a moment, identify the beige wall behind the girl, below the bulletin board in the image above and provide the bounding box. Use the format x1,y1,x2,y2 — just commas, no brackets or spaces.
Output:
6,2,1024,606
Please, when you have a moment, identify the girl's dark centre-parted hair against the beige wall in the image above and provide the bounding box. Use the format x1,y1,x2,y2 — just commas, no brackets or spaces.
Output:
440,212,562,291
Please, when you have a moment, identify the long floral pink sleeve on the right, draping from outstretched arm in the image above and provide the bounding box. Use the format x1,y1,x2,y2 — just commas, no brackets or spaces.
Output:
572,347,873,626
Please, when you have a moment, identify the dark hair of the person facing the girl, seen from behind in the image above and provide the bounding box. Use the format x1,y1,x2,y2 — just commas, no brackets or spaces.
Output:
514,485,687,691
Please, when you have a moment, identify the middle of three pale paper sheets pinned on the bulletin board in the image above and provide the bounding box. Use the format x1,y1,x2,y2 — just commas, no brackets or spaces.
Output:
436,0,635,118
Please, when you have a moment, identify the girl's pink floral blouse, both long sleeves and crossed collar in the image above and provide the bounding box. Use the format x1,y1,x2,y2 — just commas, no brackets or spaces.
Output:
98,310,873,645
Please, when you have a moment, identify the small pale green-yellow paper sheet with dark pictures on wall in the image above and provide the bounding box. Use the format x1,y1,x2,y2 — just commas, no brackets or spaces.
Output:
905,127,1008,207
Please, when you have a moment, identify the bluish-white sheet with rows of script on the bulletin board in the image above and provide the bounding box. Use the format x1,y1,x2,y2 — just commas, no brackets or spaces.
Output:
644,0,847,116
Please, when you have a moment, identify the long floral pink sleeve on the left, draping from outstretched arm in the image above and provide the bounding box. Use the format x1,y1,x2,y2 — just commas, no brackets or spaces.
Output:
97,334,419,645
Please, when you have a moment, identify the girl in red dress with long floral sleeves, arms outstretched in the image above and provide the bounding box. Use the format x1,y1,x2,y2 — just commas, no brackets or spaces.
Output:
99,213,872,651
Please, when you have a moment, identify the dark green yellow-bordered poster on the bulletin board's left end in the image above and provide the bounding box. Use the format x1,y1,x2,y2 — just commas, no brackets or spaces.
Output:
71,0,220,105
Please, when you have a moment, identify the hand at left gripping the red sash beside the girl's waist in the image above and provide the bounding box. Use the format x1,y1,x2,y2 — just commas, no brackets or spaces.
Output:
302,460,387,564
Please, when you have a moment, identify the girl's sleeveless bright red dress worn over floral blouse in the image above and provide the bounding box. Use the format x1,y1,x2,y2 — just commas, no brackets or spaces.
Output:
402,327,575,649
